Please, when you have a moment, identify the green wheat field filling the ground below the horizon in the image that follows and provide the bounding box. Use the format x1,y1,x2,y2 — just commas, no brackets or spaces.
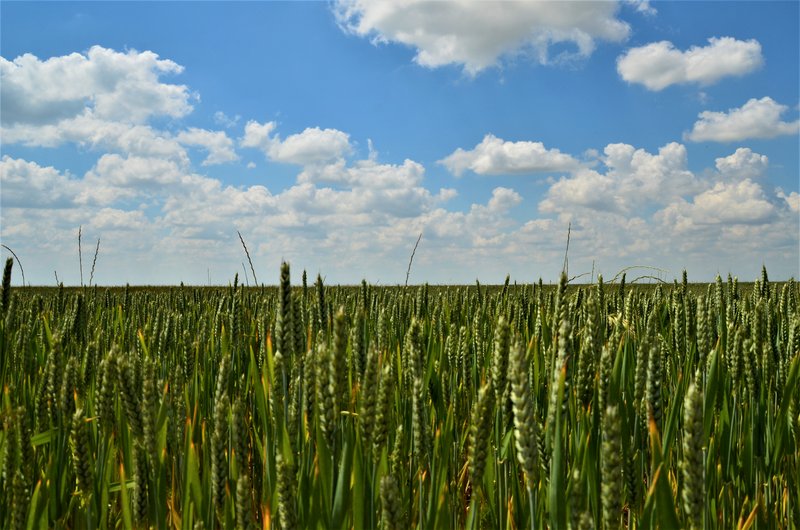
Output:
0,263,800,530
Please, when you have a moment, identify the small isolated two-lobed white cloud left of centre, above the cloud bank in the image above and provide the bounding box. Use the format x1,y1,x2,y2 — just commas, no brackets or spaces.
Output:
240,121,352,166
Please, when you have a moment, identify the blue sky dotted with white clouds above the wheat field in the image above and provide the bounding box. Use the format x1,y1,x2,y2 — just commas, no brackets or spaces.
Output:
0,1,800,284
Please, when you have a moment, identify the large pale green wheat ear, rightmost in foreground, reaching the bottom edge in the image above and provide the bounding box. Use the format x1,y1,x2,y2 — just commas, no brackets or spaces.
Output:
681,374,705,529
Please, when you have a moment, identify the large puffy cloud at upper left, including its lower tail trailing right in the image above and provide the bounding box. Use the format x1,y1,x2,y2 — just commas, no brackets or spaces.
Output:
0,46,220,175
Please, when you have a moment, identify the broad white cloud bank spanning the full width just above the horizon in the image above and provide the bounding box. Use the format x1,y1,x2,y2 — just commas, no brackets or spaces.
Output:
0,128,800,283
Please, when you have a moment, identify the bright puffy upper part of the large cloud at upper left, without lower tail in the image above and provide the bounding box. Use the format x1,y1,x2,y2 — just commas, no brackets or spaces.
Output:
0,46,192,125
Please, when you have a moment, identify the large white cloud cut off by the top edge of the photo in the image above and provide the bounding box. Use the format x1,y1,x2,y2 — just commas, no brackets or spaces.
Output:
334,0,630,75
